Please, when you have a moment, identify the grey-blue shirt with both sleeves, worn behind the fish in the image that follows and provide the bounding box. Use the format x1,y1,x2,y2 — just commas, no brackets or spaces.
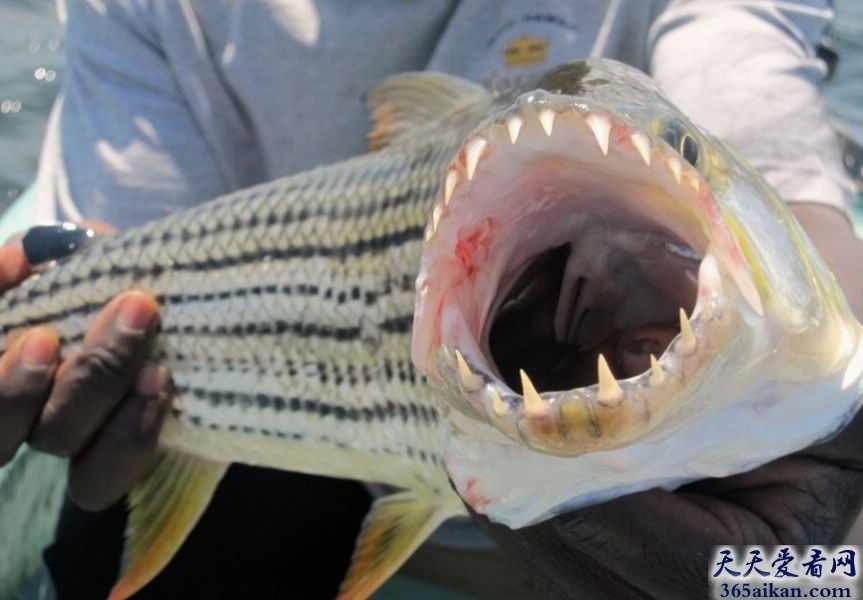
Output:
37,0,850,228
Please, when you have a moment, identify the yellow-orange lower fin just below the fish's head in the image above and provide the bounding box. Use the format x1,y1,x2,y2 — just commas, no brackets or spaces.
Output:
336,491,452,600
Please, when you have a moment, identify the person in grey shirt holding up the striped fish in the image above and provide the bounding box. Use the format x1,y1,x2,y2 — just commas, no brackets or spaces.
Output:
0,0,863,598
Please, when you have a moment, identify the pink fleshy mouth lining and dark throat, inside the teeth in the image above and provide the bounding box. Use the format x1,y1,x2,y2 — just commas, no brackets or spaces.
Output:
412,120,709,392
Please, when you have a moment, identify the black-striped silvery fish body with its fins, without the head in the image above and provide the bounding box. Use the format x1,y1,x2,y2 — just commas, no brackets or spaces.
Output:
0,74,506,600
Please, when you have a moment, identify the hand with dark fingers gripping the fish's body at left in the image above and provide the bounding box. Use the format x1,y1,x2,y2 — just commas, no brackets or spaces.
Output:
0,230,170,510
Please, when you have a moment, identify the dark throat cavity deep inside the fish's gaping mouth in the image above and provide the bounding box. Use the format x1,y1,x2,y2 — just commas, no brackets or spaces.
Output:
483,212,698,391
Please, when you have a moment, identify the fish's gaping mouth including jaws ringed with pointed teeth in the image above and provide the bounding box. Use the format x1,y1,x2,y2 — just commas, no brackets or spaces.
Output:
413,90,764,456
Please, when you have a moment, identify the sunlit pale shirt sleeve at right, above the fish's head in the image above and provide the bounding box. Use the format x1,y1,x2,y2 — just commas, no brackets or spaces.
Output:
649,0,852,210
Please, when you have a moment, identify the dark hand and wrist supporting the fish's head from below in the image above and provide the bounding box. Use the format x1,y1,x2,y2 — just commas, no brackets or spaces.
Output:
477,204,863,600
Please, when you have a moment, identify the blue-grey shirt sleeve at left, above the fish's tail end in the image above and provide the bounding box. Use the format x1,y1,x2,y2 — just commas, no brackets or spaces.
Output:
37,0,260,228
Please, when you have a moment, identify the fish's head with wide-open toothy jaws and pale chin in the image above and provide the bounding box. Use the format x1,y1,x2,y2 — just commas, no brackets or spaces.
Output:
412,60,861,526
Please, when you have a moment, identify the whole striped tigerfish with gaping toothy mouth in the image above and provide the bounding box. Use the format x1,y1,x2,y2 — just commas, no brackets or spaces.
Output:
0,59,863,600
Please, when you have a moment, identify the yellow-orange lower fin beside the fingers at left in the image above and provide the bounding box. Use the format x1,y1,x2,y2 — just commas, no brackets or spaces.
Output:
108,450,228,600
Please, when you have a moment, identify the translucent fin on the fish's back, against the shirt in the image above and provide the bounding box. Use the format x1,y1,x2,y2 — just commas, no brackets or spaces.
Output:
366,72,492,150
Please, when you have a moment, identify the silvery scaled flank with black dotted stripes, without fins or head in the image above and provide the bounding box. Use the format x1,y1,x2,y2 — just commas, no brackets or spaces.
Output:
0,127,466,486
